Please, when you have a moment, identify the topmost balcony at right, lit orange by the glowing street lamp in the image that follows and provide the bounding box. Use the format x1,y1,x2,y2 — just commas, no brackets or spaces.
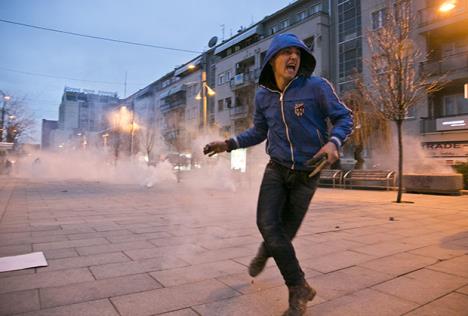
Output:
418,0,468,32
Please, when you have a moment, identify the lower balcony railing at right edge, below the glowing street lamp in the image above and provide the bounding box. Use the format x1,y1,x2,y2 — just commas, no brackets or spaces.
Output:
420,52,468,76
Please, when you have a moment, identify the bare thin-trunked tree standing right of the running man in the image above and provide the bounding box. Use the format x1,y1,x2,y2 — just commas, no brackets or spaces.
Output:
362,0,443,203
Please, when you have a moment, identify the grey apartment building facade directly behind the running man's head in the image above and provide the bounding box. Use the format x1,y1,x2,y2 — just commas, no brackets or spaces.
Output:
214,1,331,133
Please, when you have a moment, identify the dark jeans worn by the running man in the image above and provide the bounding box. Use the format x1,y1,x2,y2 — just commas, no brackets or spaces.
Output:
257,161,319,286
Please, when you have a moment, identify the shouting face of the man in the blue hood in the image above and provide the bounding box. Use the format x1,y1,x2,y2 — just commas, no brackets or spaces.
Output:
271,47,301,82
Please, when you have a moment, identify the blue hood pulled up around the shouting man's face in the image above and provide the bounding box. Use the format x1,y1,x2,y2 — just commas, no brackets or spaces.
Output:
258,33,316,89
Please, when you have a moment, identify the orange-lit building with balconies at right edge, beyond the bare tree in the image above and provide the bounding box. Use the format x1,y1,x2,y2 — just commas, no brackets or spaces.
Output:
414,0,468,164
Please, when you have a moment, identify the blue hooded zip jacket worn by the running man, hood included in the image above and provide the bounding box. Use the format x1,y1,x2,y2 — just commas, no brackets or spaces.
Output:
228,34,353,170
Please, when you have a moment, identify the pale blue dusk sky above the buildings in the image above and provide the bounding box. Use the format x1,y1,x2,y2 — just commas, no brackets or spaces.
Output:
0,0,292,141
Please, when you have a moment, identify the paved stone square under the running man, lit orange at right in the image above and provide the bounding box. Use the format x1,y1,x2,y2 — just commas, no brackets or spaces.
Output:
0,177,468,316
